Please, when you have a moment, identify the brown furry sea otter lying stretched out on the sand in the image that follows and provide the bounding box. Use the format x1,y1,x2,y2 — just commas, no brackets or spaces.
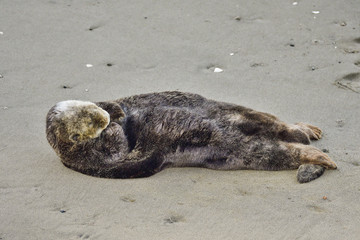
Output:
46,91,336,183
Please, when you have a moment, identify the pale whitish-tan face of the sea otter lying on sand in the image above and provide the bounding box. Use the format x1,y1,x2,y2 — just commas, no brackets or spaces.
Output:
54,100,110,143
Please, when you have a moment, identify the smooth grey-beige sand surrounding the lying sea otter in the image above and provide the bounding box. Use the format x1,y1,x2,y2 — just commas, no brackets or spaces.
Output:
0,0,360,240
